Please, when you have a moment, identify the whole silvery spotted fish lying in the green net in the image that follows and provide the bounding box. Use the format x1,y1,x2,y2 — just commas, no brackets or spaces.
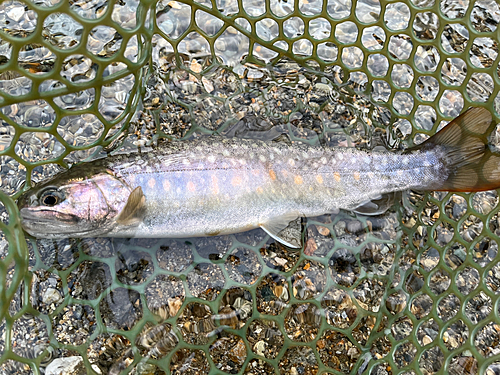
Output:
18,107,500,248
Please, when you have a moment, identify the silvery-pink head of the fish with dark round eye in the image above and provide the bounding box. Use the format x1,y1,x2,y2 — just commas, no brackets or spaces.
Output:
18,168,129,239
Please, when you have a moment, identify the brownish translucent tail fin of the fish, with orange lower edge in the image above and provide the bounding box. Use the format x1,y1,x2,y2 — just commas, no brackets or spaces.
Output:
413,107,500,192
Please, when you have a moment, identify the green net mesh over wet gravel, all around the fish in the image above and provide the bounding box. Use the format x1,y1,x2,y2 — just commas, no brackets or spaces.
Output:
0,0,500,375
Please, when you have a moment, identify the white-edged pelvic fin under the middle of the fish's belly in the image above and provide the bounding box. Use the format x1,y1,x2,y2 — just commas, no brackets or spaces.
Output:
260,213,302,249
